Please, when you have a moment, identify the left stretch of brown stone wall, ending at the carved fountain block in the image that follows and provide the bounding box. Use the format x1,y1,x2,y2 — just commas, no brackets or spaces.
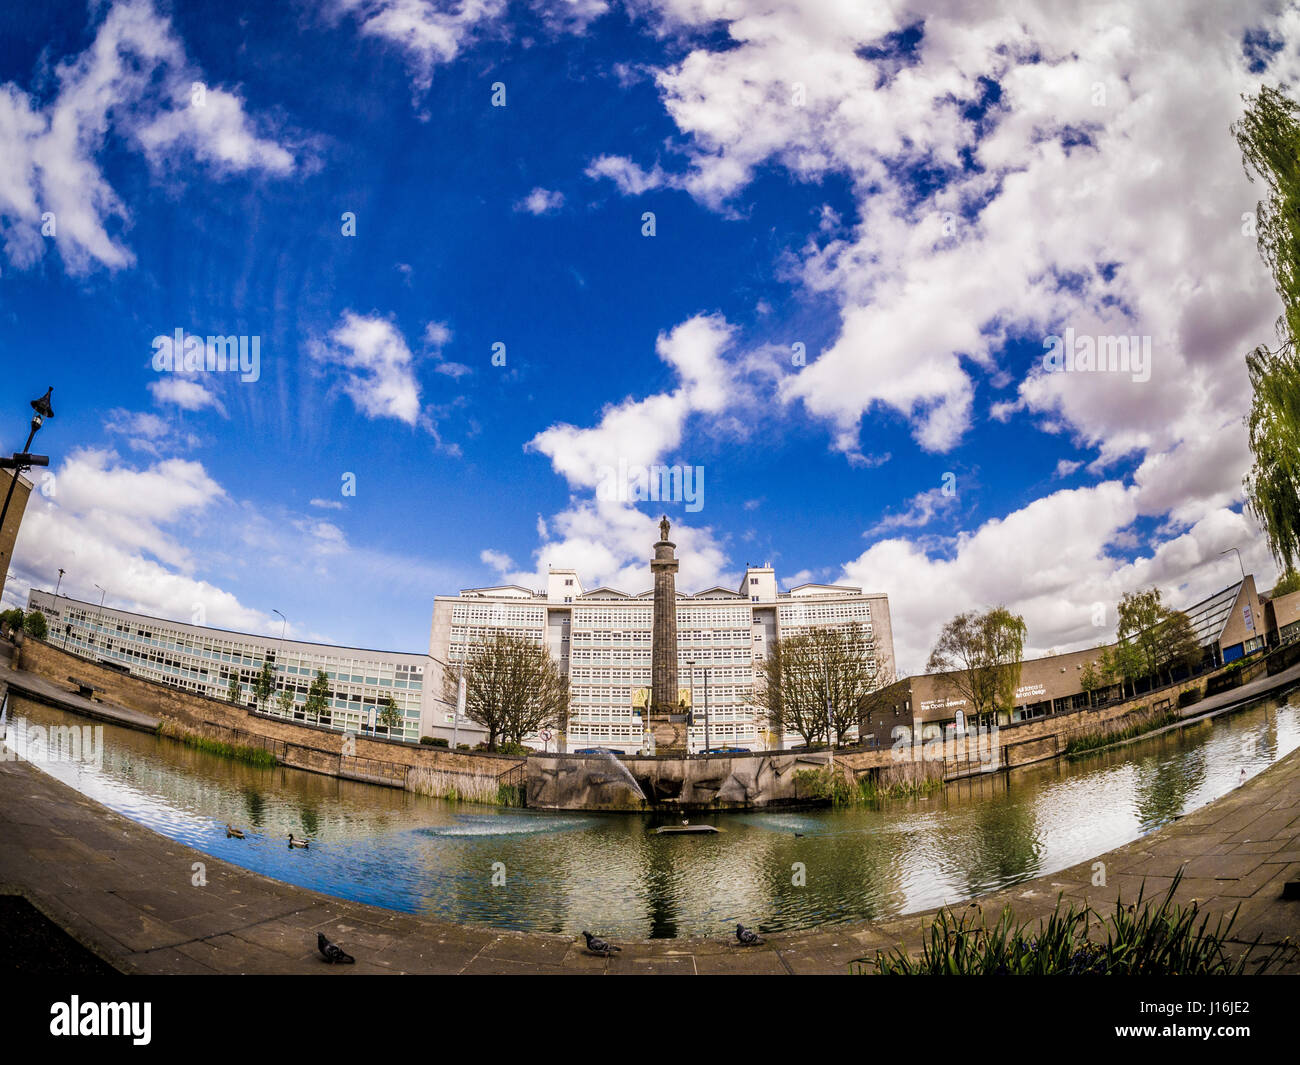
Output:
16,637,524,797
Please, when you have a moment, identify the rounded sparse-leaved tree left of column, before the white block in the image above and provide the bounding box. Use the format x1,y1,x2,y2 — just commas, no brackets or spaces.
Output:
445,632,568,750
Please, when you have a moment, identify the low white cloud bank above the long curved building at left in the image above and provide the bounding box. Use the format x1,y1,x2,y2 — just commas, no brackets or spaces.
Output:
5,449,473,646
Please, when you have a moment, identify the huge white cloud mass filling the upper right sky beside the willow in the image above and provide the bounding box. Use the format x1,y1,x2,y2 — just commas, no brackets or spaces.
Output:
572,0,1300,670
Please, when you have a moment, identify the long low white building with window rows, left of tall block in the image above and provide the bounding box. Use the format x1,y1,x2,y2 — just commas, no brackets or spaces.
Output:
27,589,432,741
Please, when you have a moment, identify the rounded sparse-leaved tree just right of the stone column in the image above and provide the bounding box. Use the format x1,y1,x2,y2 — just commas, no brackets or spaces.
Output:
754,624,885,745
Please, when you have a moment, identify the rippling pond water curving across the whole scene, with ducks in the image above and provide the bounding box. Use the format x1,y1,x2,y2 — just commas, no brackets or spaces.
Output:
8,698,1300,938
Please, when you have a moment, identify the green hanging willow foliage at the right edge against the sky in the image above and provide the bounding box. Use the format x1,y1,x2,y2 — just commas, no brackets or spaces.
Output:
1232,87,1300,571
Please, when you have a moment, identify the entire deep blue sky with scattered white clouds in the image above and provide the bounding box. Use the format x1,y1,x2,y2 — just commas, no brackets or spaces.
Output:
0,0,1297,670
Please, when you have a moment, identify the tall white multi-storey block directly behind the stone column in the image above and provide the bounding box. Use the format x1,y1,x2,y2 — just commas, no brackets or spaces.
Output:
429,566,894,752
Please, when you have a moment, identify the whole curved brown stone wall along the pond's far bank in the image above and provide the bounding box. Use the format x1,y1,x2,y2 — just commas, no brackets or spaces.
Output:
16,637,1265,810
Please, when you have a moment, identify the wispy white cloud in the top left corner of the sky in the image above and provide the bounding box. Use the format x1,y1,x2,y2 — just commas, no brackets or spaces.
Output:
0,0,295,273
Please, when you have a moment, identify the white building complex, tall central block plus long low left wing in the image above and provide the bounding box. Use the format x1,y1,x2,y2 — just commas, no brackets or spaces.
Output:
27,566,894,752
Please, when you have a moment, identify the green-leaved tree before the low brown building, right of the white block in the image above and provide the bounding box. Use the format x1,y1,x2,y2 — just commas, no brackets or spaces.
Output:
926,606,1027,726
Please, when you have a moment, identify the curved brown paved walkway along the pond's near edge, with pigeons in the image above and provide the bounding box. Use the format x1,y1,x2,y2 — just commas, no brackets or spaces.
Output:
0,750,1300,975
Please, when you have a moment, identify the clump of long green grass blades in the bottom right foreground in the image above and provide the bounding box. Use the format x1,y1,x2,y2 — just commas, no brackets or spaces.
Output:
853,873,1294,977
